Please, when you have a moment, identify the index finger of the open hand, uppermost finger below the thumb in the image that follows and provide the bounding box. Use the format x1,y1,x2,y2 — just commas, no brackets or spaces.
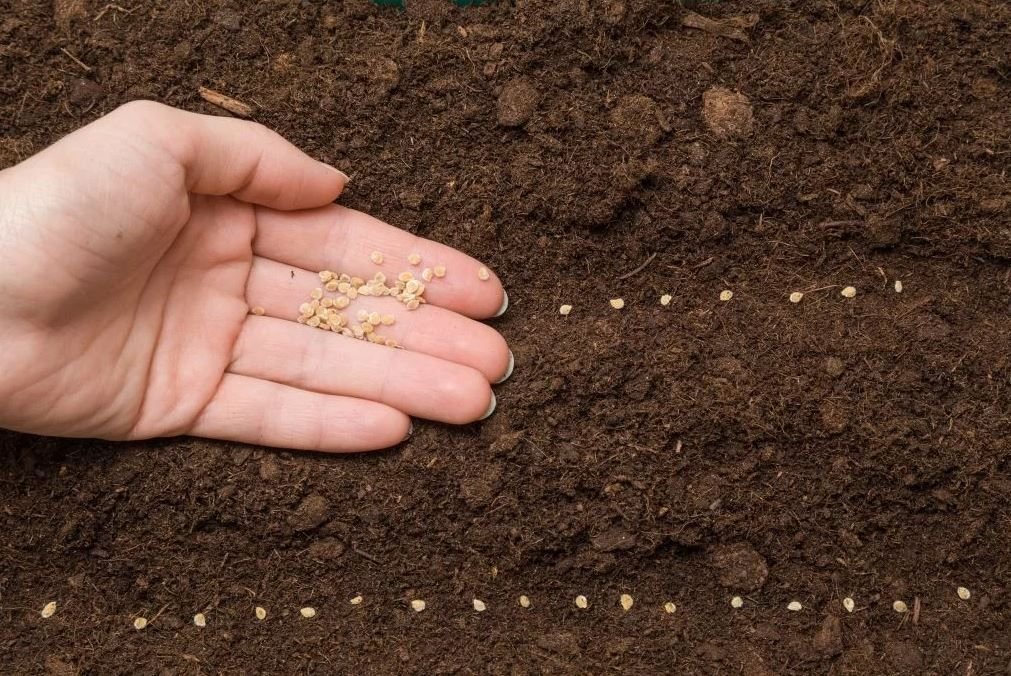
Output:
253,204,509,319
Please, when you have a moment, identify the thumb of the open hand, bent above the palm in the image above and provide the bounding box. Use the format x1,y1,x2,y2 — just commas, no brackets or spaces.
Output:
114,101,348,209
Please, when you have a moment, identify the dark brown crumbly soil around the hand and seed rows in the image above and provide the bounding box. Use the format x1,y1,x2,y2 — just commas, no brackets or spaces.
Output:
0,0,1011,676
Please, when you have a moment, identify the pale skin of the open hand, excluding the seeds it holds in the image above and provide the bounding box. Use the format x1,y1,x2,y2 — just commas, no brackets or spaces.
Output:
0,102,513,452
